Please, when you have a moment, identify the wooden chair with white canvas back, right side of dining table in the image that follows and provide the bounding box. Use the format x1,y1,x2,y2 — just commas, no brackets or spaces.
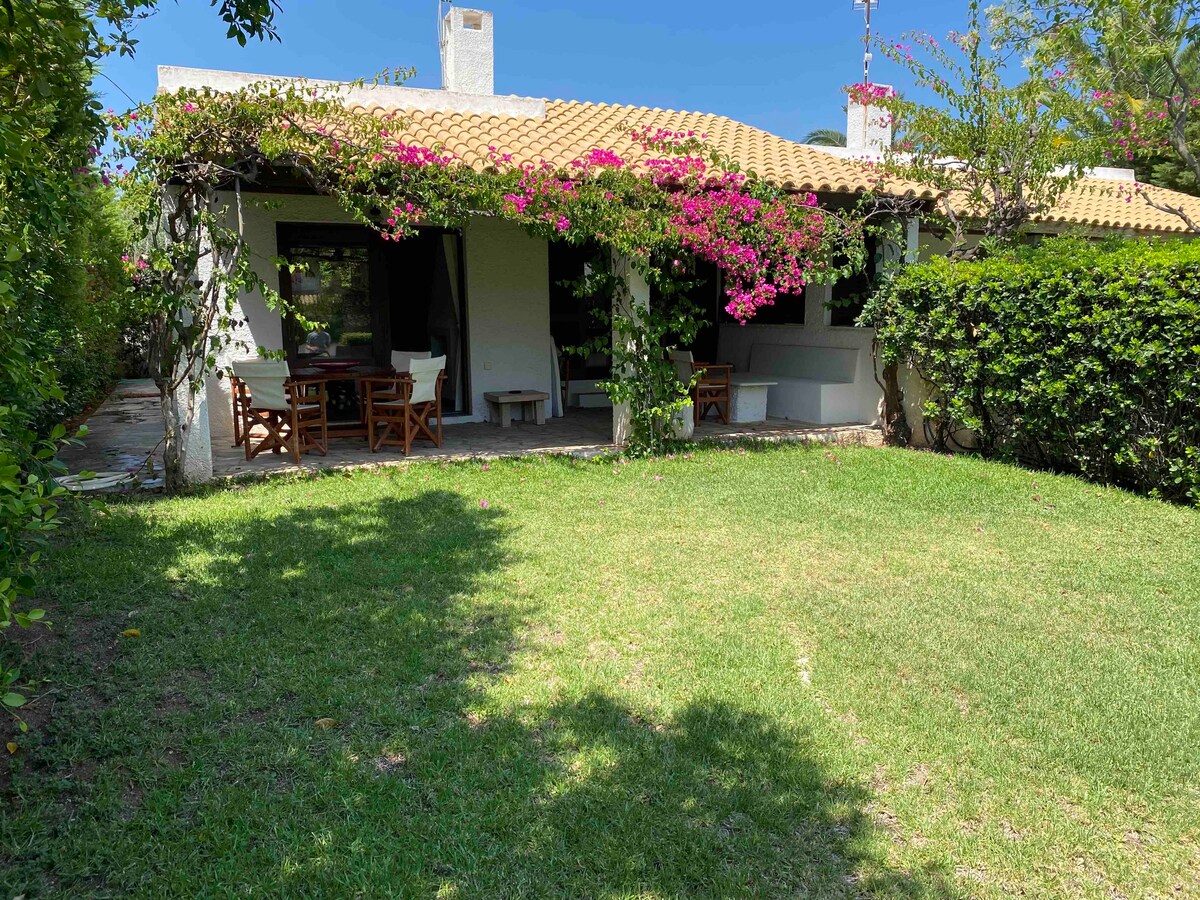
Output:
362,356,446,456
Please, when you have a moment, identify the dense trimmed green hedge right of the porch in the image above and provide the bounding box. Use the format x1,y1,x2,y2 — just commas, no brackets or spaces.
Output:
864,238,1200,503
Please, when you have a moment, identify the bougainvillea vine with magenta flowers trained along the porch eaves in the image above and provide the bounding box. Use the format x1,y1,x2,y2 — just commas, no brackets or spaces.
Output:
107,75,863,468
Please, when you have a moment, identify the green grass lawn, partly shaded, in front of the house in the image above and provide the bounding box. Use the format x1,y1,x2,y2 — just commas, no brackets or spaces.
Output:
0,448,1200,899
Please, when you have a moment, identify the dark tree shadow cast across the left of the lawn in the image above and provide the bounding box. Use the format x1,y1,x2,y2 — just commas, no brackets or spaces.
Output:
0,487,953,896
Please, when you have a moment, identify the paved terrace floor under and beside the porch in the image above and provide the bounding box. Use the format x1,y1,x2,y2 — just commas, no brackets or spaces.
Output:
61,380,880,487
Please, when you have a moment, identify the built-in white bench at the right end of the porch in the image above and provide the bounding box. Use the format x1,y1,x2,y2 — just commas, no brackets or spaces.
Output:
748,343,862,425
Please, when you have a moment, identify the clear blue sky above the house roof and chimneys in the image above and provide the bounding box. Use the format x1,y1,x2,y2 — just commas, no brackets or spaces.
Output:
96,0,966,139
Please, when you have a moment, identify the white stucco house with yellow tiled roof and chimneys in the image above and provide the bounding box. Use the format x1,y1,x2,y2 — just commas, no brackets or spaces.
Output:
158,7,1194,475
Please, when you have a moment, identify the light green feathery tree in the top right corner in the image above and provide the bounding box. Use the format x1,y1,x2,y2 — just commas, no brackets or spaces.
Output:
994,0,1200,230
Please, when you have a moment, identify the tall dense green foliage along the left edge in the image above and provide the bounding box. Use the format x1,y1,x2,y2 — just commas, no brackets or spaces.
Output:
0,0,278,724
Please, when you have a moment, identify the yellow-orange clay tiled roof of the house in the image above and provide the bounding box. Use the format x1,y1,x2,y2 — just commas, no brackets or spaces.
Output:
350,100,1200,233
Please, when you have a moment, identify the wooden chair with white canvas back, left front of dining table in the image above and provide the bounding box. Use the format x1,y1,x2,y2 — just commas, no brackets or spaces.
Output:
233,360,329,464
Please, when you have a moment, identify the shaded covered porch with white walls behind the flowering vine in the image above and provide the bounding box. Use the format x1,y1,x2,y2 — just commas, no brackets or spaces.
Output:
180,193,877,478
